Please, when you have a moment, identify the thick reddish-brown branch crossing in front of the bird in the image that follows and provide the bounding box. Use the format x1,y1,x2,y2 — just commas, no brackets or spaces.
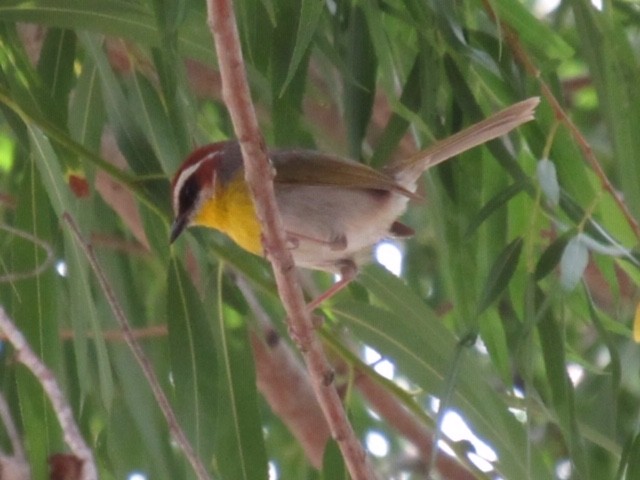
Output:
207,0,375,480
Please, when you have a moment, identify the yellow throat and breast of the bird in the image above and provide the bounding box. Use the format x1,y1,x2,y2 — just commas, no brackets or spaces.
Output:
194,170,263,255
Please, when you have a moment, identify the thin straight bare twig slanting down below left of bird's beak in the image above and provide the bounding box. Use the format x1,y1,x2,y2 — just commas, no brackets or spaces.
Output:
62,212,211,480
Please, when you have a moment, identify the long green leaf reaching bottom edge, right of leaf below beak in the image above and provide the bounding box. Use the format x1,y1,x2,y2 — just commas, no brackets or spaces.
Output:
214,268,267,480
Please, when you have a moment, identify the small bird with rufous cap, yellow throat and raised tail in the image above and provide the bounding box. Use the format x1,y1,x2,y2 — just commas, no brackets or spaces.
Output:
169,97,540,303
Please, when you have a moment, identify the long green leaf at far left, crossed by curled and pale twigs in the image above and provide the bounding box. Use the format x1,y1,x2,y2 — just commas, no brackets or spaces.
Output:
8,161,65,478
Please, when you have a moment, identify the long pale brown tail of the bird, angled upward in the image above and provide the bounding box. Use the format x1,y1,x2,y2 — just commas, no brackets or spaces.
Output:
385,97,540,189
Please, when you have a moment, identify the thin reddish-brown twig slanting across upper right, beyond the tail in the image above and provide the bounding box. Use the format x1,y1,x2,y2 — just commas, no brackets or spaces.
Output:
483,4,640,240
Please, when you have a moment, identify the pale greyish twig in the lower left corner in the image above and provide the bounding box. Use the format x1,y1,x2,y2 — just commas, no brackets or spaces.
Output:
0,307,98,480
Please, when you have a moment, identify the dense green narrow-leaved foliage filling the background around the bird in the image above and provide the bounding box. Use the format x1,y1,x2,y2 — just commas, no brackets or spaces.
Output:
0,0,640,480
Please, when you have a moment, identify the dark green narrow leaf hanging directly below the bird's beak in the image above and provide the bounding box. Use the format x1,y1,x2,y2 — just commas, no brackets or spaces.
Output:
167,257,220,463
